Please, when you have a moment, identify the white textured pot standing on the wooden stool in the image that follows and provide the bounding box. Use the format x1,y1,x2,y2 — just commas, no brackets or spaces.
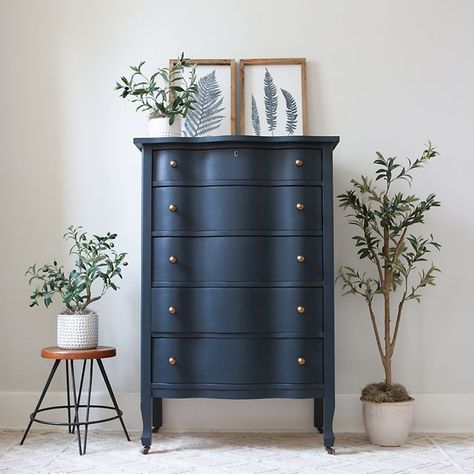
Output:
57,313,99,350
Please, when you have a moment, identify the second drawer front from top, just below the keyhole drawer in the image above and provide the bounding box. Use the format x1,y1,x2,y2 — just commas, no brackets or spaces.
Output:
153,186,322,231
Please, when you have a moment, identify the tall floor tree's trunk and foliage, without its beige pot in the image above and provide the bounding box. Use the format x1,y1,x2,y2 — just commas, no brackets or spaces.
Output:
337,142,441,389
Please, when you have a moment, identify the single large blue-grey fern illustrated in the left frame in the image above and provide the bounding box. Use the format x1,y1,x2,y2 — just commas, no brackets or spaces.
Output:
184,69,225,137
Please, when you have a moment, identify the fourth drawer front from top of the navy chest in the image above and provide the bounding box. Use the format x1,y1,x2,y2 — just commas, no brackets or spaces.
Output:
151,288,323,336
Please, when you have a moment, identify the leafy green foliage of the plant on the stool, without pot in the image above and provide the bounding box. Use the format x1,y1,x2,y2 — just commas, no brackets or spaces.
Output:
26,226,127,314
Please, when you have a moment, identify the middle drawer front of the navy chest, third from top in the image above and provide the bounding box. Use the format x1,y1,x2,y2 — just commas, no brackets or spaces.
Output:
152,236,323,282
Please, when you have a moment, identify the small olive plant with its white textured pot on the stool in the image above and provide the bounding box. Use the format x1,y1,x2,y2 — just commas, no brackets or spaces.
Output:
26,226,127,349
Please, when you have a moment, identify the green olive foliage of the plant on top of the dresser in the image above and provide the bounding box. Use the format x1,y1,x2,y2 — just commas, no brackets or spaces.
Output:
115,53,197,125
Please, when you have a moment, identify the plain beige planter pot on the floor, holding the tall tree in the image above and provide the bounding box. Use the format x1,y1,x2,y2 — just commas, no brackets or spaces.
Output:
362,400,415,446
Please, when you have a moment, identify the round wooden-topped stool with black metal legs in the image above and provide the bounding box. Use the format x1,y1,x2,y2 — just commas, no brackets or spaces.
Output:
20,346,130,455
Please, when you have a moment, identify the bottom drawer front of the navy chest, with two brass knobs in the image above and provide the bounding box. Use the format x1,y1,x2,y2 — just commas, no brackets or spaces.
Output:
152,338,323,384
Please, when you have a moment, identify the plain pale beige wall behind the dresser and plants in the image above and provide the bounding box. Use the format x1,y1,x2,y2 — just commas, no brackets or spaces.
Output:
0,0,474,428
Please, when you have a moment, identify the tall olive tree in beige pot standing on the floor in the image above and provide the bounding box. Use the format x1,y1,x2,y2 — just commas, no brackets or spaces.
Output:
338,143,440,446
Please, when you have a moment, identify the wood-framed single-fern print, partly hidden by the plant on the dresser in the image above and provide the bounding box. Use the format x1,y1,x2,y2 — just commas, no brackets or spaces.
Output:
170,59,235,137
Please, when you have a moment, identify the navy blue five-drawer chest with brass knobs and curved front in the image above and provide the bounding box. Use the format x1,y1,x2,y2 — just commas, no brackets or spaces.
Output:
135,136,339,453
